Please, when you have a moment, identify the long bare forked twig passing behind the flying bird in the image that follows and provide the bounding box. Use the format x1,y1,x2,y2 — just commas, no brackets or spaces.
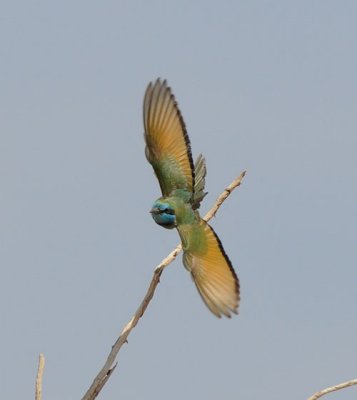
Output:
82,171,245,400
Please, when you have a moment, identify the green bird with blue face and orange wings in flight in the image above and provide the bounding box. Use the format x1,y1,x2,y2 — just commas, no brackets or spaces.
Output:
143,78,240,318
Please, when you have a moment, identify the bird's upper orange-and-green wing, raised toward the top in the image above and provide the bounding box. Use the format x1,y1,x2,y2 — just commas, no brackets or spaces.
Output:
144,79,195,196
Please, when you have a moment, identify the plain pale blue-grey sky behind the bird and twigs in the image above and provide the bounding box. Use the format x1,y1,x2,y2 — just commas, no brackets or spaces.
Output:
0,0,357,400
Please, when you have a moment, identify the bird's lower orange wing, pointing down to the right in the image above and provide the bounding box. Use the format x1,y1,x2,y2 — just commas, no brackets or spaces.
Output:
183,220,240,318
